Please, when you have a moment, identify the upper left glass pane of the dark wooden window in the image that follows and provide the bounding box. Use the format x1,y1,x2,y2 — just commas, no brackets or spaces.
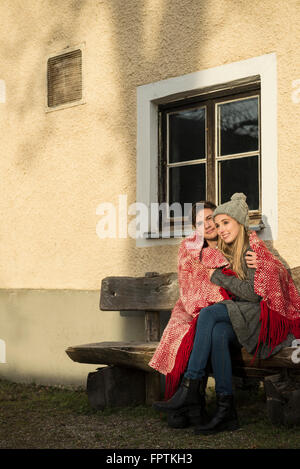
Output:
169,107,206,163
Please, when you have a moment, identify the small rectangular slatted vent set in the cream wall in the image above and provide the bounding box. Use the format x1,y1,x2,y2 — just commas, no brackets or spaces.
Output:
47,49,82,107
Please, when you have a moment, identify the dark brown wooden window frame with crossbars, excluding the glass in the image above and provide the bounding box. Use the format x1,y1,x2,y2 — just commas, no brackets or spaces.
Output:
158,76,262,236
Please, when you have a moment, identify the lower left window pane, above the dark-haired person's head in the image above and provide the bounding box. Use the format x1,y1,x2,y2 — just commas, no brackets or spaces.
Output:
169,164,206,209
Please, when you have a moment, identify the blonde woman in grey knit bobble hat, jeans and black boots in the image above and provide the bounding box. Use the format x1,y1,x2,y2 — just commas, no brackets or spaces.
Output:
154,194,300,434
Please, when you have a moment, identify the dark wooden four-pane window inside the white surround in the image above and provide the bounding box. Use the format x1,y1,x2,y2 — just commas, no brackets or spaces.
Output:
158,80,261,234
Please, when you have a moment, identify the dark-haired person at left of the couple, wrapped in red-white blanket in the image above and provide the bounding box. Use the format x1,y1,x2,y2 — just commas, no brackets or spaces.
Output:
149,201,228,427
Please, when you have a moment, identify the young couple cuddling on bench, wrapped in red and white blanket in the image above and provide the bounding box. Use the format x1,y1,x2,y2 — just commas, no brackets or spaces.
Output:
149,193,300,434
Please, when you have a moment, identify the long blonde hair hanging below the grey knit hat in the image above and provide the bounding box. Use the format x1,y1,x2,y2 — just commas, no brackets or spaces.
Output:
218,224,249,280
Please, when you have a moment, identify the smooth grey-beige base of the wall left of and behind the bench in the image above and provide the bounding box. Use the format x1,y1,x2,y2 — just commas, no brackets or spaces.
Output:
0,289,144,387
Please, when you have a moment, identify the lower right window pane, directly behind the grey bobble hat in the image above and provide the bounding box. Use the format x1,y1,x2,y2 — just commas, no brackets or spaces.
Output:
218,156,259,210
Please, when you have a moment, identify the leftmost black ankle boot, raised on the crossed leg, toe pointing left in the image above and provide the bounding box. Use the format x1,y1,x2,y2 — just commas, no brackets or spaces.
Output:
153,378,206,412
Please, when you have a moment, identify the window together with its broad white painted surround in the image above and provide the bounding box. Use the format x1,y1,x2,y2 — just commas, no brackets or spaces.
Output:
136,53,278,247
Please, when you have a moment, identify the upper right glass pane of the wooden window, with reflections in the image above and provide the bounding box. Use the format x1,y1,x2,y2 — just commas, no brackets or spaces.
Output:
218,97,258,156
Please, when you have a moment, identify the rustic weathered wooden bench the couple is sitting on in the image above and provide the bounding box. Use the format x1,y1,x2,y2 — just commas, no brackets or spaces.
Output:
66,267,300,424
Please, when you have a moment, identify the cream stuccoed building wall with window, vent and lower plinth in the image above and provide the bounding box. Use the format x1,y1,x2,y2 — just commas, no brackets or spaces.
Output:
0,0,300,384
